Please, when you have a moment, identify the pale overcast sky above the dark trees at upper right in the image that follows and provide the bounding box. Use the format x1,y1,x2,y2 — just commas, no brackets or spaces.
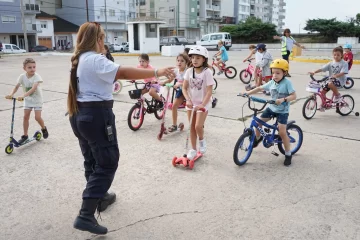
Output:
285,0,360,33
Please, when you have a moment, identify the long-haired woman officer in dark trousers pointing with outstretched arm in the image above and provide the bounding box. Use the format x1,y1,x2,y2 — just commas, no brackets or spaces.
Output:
67,22,175,234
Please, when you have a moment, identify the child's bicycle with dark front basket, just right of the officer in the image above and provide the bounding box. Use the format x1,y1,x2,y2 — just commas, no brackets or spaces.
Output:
128,81,166,131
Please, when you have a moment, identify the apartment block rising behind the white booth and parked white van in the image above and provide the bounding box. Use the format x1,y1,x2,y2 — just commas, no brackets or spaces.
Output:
136,0,234,42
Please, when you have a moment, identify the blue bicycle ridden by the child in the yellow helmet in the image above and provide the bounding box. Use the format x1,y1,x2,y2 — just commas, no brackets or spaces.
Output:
234,95,303,166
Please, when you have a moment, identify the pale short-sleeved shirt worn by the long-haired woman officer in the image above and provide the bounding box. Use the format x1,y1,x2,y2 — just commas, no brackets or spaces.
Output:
77,52,120,102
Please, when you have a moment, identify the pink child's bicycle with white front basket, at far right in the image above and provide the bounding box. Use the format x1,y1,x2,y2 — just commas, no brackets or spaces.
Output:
302,75,359,119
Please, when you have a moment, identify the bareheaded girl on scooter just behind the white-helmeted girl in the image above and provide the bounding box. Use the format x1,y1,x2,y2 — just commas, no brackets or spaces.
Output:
168,53,190,132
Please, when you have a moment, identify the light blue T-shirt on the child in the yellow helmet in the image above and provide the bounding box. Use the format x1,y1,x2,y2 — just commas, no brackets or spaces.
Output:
262,78,295,113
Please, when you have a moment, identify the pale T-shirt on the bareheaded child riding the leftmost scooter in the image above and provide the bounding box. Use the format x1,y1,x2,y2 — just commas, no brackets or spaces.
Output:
17,73,43,107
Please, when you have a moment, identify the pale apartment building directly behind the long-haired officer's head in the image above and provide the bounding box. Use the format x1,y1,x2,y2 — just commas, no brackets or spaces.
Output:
55,0,136,44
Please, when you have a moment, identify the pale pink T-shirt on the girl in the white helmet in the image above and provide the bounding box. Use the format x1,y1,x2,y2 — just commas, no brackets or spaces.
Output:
184,68,215,109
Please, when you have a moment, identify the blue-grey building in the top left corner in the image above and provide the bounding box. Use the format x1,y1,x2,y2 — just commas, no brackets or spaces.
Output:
0,0,42,49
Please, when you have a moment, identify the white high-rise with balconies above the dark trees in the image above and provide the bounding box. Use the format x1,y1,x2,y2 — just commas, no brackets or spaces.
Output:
235,0,286,31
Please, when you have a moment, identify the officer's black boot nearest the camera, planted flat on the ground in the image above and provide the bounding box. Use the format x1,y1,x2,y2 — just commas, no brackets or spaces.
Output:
74,199,107,234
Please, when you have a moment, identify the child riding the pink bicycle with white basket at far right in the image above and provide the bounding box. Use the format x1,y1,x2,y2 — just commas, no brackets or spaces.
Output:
309,47,348,103
